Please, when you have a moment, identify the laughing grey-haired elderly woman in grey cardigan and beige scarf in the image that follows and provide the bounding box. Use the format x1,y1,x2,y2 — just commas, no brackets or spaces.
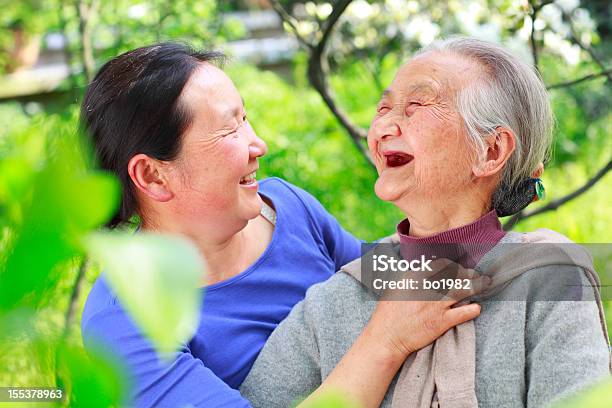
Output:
241,39,610,408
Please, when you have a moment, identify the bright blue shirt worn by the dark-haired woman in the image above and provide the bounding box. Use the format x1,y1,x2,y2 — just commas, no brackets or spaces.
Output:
81,178,360,408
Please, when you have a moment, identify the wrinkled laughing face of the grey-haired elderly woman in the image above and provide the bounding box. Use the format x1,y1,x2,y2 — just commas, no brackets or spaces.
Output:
368,53,478,208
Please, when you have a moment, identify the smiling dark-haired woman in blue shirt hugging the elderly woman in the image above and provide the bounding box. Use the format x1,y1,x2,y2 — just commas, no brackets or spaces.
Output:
82,44,492,407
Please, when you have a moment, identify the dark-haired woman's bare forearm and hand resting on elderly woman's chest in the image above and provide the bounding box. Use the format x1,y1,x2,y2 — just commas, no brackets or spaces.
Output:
300,259,490,407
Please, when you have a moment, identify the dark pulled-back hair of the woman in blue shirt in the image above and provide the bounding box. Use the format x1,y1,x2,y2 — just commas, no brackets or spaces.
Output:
81,43,224,228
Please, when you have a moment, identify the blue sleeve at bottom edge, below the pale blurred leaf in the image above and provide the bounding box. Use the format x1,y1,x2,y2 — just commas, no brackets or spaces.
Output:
83,305,251,408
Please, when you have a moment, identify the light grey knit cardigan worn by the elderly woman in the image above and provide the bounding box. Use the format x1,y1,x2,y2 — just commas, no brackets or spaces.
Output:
240,233,610,408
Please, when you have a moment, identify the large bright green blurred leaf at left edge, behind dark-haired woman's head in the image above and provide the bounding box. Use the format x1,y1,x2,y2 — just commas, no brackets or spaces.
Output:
0,131,119,313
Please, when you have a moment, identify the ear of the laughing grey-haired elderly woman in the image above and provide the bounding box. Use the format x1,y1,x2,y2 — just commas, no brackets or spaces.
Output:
472,126,516,177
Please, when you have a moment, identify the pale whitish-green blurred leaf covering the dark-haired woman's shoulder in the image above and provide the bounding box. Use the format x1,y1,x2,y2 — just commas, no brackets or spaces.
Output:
86,232,205,354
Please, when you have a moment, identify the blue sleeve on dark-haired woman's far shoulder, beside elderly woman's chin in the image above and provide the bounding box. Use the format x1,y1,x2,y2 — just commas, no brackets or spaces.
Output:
283,181,362,270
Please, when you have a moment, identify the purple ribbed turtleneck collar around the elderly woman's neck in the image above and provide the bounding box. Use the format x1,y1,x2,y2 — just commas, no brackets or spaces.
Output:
397,210,506,268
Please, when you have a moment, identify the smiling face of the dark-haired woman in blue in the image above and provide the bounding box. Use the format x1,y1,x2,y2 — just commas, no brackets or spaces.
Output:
166,64,267,228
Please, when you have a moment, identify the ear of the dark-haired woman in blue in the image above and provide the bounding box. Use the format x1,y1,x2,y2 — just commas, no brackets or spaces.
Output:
128,153,174,202
